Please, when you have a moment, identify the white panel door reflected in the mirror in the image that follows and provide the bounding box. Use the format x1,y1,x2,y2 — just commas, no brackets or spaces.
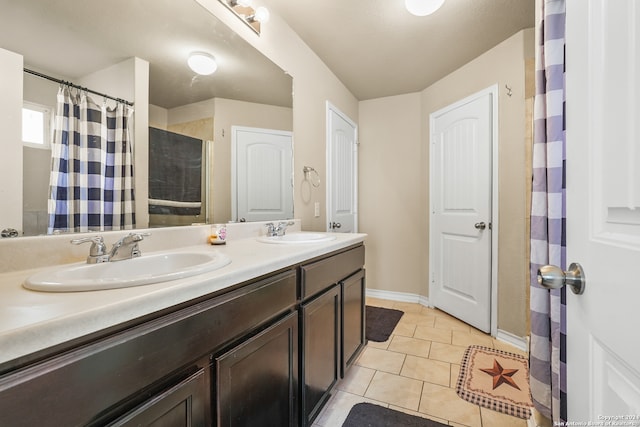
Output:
231,126,293,222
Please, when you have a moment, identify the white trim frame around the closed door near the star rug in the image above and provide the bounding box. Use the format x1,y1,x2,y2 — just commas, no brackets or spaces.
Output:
429,83,500,337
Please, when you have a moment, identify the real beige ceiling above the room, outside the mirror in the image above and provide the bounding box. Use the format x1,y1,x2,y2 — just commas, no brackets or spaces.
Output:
258,0,535,100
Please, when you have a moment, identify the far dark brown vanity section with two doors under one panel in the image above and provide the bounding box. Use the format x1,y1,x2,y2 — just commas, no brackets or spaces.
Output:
300,246,365,426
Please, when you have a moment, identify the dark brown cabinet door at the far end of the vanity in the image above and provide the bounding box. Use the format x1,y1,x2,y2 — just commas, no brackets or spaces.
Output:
340,270,365,378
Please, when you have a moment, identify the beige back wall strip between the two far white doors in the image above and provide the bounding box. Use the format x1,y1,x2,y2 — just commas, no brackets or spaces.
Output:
358,93,428,296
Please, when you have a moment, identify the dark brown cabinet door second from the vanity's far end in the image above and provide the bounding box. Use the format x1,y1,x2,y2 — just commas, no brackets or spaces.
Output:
301,285,340,425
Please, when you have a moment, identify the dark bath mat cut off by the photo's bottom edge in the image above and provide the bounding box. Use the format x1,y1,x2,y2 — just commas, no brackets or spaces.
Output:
342,403,446,427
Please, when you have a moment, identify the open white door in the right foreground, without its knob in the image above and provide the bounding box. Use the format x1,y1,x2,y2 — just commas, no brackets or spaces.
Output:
566,0,640,426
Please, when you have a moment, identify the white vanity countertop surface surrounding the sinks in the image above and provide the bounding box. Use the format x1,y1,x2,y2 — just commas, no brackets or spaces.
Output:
0,233,366,364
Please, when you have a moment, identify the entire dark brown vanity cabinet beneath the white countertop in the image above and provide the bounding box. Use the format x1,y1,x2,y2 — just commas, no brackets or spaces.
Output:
0,244,365,427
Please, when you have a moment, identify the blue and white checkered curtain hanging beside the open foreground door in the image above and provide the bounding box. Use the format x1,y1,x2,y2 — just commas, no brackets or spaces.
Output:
529,0,567,422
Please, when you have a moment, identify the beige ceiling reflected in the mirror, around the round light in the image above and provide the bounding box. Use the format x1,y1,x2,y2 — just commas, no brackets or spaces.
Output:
0,0,292,109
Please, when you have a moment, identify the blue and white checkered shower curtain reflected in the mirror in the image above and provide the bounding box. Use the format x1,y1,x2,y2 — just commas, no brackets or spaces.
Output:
47,86,135,234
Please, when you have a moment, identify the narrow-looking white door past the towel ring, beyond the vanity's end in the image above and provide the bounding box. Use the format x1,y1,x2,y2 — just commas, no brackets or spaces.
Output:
327,103,358,233
